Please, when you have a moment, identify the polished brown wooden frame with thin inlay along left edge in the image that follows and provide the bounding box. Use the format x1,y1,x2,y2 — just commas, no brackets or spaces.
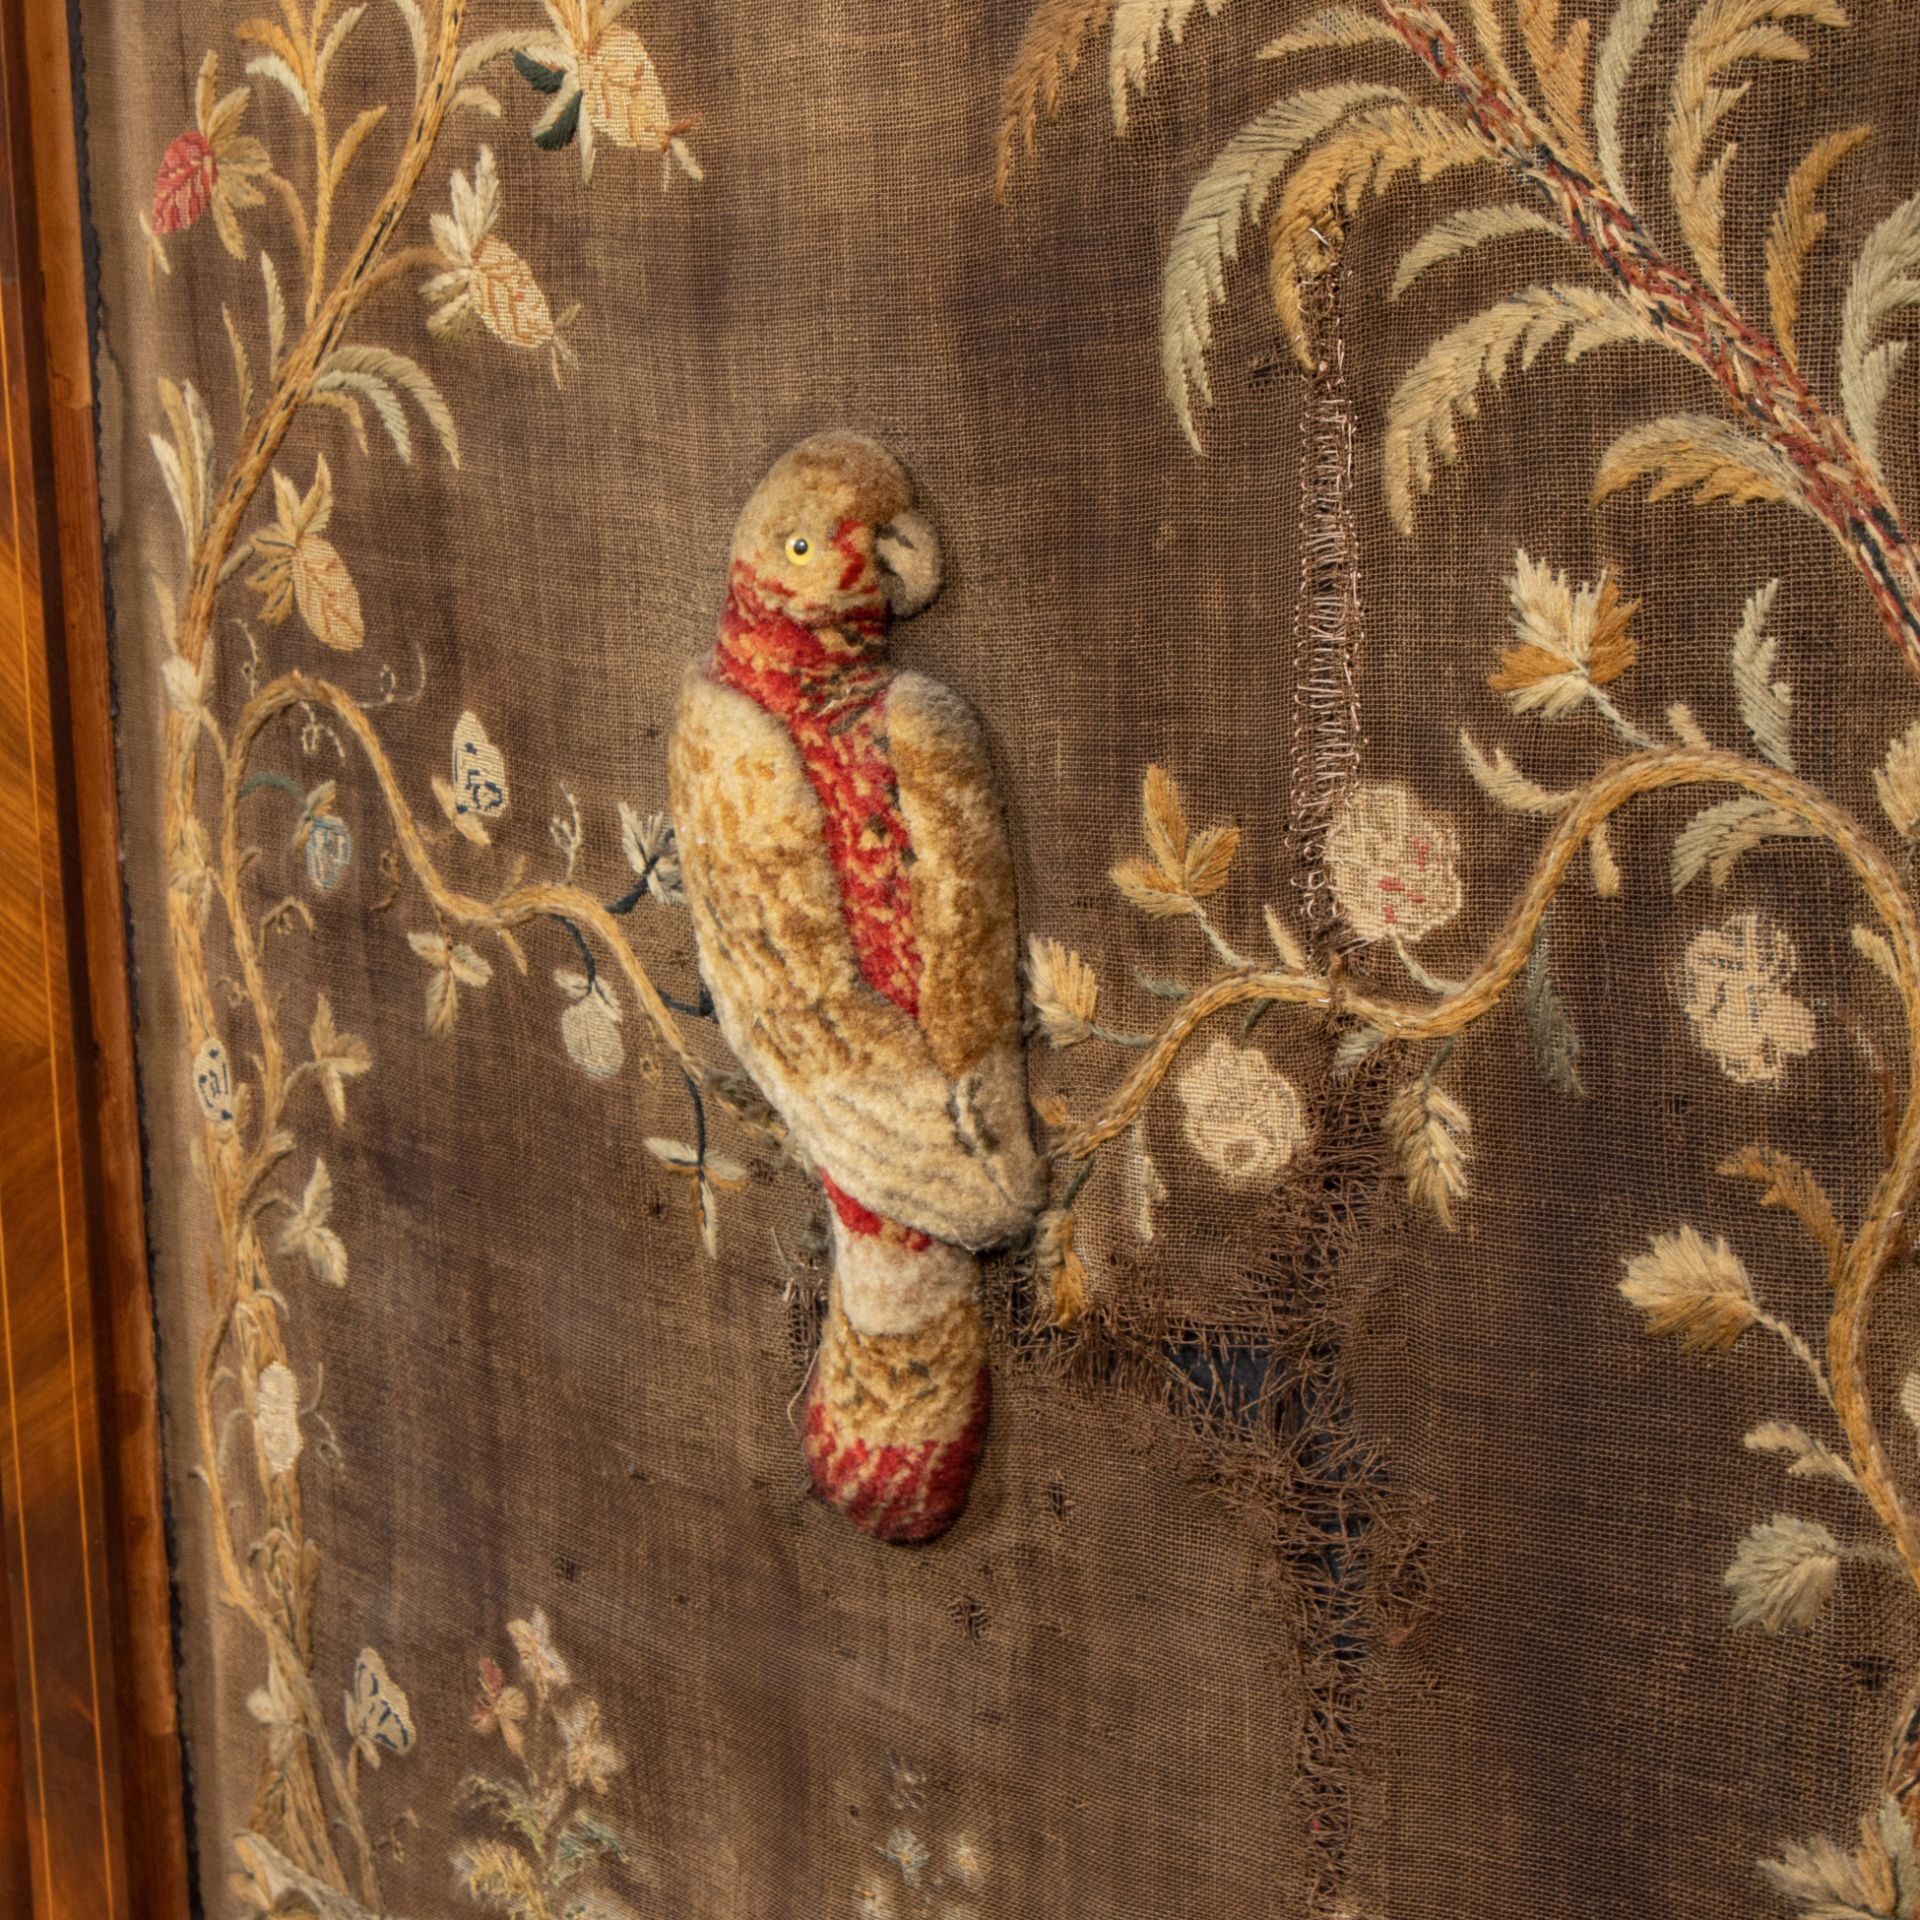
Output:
0,0,188,1920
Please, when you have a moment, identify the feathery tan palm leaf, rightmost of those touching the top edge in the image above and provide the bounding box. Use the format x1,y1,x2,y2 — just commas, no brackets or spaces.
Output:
1667,0,1847,294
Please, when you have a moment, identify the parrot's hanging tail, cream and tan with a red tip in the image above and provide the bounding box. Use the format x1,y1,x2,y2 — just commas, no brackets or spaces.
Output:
804,1183,989,1542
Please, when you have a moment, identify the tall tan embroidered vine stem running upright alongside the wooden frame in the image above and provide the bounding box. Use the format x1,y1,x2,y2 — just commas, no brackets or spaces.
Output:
165,0,472,1910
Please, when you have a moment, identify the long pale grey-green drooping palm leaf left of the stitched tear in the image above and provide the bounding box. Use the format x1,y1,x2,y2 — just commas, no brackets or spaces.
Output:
1160,81,1407,453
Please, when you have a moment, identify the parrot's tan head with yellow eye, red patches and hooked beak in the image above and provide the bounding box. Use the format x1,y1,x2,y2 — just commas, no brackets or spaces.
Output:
730,434,941,643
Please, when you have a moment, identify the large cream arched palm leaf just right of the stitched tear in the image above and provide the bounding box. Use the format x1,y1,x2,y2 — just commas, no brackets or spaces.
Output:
1382,284,1663,534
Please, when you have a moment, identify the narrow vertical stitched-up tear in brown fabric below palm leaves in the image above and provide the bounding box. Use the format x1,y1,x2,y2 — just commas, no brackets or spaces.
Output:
1286,243,1365,943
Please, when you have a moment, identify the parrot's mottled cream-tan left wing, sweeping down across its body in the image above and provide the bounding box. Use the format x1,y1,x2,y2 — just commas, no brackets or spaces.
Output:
668,668,1035,1246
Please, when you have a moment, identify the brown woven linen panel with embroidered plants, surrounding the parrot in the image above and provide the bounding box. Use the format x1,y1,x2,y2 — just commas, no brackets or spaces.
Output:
79,0,1920,1920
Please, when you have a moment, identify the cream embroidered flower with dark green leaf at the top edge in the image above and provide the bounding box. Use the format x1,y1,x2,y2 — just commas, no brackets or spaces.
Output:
513,0,703,182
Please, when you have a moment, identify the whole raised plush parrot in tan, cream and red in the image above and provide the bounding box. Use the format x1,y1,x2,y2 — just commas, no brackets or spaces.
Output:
670,434,1044,1542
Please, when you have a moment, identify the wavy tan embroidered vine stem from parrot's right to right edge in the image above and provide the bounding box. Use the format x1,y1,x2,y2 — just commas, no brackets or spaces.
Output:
1060,749,1920,1588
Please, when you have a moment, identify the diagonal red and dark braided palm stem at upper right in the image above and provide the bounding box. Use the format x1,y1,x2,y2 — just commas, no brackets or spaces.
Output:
1375,0,1920,674
